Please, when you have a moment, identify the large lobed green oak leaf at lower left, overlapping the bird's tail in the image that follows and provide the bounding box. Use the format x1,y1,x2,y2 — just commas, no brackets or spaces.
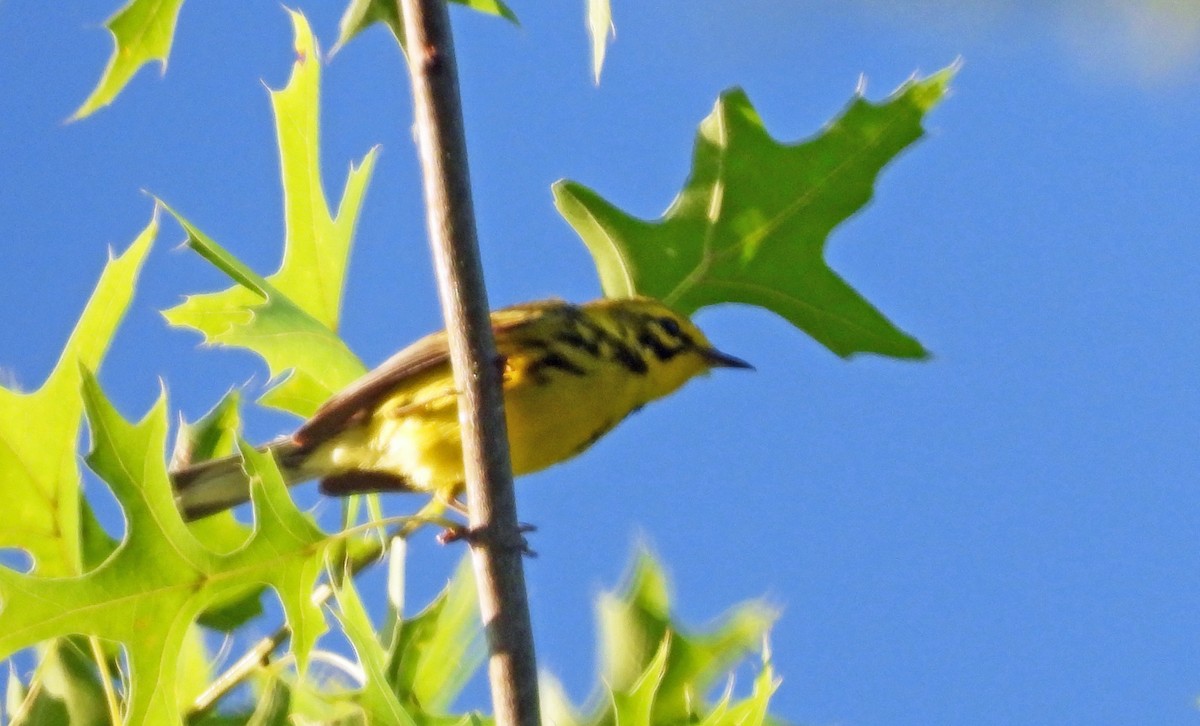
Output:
0,368,332,724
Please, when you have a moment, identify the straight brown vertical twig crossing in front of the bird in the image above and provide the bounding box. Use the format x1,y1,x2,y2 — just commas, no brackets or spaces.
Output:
397,0,540,726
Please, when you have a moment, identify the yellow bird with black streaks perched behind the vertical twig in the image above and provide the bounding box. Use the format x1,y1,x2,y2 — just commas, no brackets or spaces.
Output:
170,296,754,520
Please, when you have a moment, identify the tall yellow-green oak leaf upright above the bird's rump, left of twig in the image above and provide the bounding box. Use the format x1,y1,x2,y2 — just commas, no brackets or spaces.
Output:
163,12,376,416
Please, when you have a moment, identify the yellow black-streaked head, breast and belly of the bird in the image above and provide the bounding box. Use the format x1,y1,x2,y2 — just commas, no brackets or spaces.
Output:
306,294,710,496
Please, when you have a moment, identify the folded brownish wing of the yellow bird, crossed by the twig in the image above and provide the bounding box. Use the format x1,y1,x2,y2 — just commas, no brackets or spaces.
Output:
292,301,566,450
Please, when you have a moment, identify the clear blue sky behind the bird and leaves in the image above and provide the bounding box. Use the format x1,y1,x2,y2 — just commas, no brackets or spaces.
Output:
0,0,1200,725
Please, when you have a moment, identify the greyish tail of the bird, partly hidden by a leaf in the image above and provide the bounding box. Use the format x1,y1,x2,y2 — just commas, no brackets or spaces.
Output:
170,439,311,520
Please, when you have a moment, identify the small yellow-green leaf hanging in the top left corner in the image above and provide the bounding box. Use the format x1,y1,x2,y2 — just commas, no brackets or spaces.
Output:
71,0,184,121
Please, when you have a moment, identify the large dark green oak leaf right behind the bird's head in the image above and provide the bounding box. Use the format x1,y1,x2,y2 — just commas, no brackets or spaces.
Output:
554,66,958,359
